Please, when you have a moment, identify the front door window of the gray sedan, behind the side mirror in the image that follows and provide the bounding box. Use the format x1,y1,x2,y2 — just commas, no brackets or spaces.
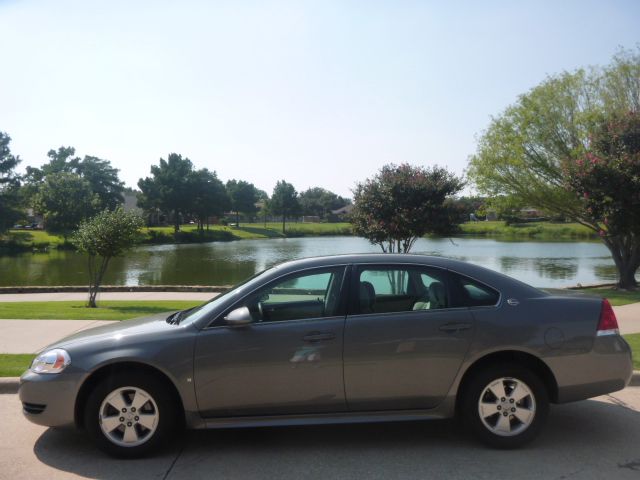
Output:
236,267,344,322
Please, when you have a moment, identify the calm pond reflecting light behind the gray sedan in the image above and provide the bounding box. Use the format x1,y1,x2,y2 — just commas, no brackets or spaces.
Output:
0,237,616,287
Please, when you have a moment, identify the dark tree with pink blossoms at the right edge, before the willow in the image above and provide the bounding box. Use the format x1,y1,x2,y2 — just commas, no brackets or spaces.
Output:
565,112,640,289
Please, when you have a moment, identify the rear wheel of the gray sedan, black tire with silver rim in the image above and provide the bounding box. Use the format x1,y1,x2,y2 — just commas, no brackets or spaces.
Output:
460,365,549,449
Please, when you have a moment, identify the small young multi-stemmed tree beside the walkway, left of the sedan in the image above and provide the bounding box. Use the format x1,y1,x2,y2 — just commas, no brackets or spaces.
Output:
72,207,143,308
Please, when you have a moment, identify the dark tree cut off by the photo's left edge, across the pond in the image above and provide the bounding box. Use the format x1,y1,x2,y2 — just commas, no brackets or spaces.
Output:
0,132,21,234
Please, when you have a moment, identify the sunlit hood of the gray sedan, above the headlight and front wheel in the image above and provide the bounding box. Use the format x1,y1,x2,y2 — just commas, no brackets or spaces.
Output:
41,312,175,351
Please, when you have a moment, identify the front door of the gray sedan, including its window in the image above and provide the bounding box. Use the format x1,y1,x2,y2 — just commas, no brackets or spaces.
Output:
194,266,346,417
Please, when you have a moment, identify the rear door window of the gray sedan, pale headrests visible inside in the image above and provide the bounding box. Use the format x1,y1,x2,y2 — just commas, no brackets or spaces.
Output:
355,267,450,314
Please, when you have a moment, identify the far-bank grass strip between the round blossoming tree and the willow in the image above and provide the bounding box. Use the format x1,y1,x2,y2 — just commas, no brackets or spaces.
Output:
460,221,598,240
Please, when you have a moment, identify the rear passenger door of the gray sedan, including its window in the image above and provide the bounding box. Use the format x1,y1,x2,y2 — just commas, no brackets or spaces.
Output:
344,265,474,411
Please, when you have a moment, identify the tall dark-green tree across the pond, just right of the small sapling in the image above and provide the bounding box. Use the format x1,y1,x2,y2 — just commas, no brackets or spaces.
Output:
138,153,193,232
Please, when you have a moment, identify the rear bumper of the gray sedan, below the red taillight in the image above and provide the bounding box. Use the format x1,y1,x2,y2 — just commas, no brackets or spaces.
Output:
546,335,633,403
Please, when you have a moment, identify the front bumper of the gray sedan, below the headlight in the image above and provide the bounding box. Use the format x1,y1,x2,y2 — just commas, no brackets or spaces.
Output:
18,370,82,427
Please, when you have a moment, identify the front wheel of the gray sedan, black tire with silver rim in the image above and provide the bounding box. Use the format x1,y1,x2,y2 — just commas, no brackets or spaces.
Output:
84,372,181,458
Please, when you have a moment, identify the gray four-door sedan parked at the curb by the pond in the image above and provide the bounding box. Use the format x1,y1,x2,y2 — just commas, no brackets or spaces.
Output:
20,255,632,457
